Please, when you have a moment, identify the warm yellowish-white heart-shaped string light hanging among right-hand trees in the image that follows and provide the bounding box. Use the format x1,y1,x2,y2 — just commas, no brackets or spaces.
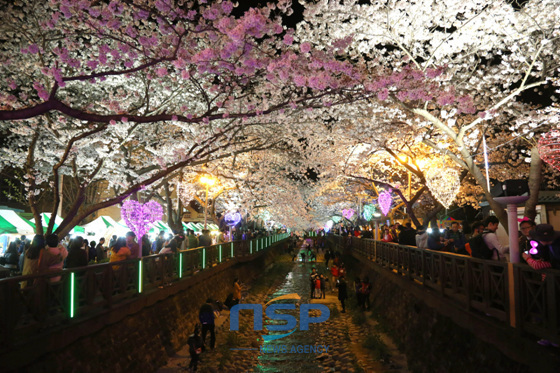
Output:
425,161,461,209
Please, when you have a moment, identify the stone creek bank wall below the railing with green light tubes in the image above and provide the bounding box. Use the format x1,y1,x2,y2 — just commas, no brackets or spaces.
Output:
5,242,287,373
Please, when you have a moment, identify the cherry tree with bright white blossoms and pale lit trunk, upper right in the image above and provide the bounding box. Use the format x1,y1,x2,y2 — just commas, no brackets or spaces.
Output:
297,0,560,227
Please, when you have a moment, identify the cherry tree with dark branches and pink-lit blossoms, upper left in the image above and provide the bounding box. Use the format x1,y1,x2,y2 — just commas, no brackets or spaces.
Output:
0,0,384,235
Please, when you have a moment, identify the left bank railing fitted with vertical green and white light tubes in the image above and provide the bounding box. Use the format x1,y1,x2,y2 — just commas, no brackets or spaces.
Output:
0,233,289,346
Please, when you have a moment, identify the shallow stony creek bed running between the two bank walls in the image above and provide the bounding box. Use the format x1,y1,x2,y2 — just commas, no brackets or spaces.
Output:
158,243,407,373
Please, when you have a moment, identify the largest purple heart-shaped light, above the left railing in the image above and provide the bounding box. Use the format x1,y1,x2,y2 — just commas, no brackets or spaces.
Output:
121,199,163,241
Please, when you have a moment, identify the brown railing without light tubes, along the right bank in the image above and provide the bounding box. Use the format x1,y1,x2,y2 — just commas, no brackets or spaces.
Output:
329,235,560,343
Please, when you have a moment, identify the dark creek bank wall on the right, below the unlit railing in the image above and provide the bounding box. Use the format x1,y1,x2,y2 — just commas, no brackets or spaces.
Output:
345,249,560,373
